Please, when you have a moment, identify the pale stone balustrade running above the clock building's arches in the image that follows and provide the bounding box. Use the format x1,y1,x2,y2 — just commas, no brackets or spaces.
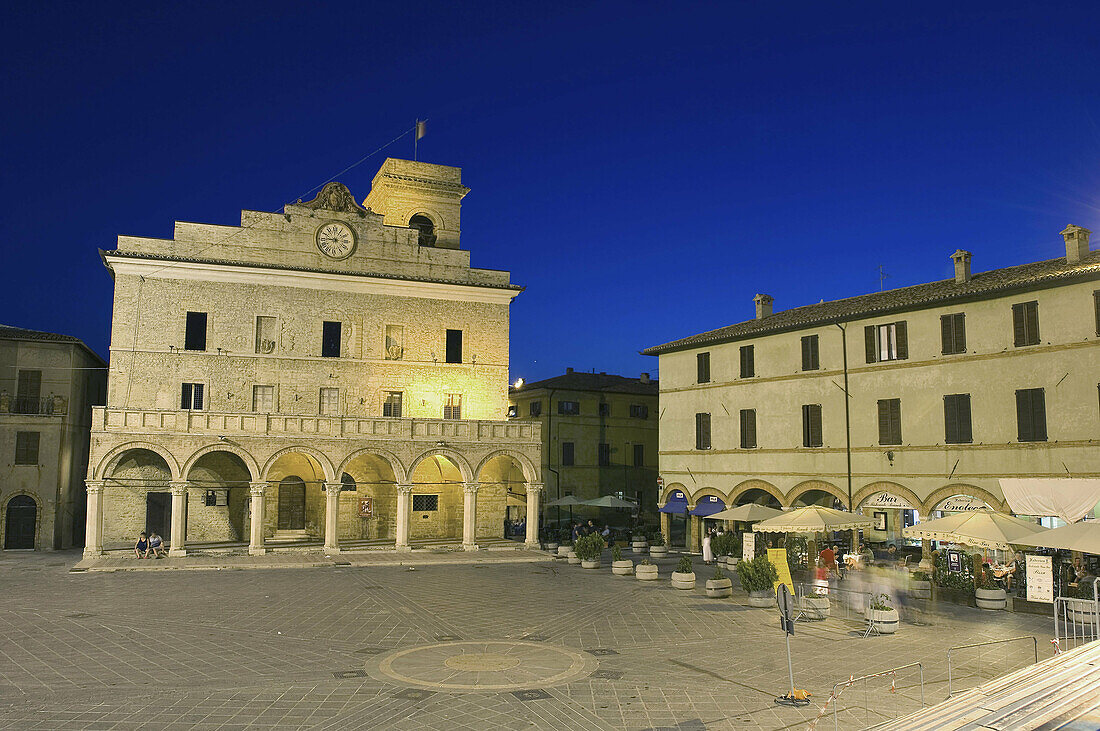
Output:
91,407,542,443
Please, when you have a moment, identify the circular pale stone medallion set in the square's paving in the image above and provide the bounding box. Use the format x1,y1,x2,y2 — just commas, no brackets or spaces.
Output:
366,641,600,693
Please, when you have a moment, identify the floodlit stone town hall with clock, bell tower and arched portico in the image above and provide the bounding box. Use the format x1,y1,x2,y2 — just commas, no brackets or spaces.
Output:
88,159,541,554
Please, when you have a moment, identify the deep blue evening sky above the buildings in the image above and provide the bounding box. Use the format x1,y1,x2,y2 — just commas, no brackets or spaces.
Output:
0,0,1100,380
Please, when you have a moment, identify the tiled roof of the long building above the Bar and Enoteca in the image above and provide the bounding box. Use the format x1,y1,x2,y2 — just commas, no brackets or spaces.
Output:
641,252,1100,355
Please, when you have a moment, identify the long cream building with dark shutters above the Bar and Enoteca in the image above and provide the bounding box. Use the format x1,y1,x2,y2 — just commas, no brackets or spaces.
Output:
645,226,1100,547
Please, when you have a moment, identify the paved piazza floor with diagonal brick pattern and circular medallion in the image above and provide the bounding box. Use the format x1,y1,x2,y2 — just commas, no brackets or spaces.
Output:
0,552,1052,731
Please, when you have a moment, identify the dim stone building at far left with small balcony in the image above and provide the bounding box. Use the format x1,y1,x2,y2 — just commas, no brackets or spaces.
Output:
0,326,107,551
